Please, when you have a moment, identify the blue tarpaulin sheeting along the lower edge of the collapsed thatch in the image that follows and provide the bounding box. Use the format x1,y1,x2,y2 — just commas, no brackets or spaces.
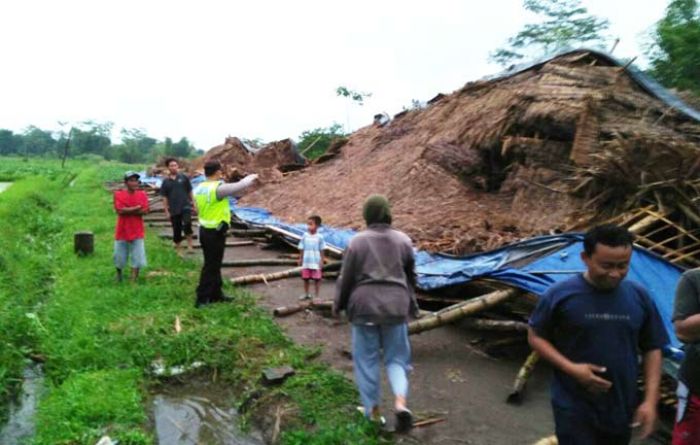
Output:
223,206,683,359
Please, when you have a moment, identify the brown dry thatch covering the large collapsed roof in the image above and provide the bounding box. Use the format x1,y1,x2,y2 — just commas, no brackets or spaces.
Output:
232,51,700,253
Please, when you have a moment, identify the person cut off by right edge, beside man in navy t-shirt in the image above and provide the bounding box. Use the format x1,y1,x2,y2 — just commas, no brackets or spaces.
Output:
671,268,700,445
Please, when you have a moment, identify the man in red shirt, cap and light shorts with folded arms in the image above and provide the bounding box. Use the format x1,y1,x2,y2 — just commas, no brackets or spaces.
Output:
114,171,148,282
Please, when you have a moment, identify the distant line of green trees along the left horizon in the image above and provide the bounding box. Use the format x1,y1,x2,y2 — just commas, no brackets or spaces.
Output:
0,121,204,163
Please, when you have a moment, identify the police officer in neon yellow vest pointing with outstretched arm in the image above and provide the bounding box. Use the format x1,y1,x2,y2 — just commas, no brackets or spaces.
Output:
193,161,258,307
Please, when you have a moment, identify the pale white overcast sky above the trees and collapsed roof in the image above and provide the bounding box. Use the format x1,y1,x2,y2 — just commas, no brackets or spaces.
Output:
0,0,667,149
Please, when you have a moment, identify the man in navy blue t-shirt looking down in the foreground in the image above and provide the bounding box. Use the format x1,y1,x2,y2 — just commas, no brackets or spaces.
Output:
529,225,668,445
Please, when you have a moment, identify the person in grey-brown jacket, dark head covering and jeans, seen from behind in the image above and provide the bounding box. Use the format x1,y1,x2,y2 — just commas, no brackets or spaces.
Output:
333,195,418,432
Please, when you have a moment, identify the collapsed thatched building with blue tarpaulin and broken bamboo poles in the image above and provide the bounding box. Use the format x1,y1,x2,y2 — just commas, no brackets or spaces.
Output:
164,50,700,438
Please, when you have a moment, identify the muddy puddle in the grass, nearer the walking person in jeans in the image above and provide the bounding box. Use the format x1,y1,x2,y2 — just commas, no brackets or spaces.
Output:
153,384,264,445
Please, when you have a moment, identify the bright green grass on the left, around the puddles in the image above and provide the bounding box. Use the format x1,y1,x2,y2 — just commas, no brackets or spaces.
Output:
0,160,385,444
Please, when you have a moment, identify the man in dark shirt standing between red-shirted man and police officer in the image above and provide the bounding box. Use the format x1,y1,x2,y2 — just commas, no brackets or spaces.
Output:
160,158,194,253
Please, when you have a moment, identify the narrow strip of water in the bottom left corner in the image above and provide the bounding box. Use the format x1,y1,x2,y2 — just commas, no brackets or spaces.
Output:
0,365,44,444
